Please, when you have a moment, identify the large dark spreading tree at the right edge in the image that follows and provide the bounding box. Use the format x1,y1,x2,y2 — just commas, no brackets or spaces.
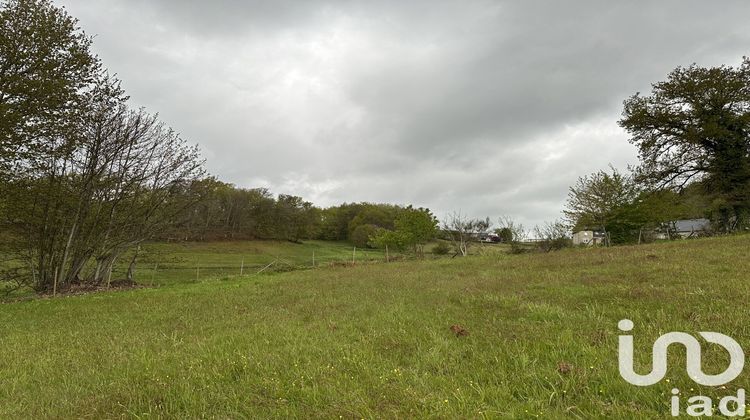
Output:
620,57,750,230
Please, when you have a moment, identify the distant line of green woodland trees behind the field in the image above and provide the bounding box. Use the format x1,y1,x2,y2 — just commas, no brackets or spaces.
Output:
157,177,438,251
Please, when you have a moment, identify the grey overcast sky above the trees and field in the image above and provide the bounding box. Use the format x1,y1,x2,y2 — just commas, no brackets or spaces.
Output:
56,0,750,226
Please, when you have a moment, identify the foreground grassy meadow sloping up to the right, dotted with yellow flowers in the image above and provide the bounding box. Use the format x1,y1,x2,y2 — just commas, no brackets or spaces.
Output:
0,236,750,419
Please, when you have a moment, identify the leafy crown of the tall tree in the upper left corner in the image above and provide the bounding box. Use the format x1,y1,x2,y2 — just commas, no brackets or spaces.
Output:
0,0,101,176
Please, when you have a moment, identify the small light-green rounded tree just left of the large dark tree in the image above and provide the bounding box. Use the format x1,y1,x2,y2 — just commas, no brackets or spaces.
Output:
563,169,638,244
